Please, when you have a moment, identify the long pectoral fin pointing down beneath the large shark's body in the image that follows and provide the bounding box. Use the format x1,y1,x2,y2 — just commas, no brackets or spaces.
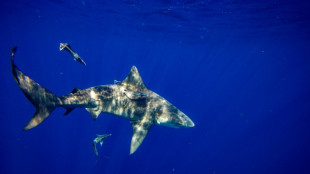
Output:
130,118,153,155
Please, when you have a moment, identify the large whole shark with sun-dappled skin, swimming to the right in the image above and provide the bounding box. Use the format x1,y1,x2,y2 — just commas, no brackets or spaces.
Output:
11,47,194,154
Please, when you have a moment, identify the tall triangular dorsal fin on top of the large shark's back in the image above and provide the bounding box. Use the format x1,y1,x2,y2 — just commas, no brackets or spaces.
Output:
119,66,146,89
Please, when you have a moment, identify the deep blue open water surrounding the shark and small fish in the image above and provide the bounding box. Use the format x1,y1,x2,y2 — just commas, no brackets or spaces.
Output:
0,0,310,174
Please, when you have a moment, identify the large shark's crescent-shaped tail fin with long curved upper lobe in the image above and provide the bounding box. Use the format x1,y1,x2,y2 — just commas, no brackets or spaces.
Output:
11,46,60,130
